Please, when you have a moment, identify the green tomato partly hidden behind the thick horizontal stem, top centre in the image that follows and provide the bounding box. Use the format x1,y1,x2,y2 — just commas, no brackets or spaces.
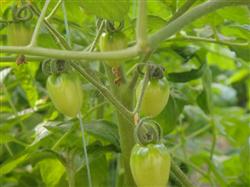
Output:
99,32,128,67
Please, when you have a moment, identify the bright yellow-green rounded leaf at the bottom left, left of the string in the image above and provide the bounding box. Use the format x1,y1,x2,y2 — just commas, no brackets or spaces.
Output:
39,159,65,187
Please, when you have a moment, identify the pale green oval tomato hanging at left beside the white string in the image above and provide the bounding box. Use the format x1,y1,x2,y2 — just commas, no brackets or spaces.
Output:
46,73,83,117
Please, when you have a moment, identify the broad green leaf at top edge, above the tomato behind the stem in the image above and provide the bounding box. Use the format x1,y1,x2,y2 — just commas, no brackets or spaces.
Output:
81,0,129,21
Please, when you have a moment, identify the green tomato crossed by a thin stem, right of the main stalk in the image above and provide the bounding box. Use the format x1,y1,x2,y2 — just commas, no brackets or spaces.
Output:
136,78,169,117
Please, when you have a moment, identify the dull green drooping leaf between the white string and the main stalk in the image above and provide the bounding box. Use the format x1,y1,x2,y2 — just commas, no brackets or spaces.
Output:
84,120,120,148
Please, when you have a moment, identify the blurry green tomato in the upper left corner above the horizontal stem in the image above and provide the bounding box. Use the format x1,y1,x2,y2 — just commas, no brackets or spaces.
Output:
8,22,33,46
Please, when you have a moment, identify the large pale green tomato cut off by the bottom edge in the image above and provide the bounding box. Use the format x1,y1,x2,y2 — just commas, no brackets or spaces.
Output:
130,144,171,187
